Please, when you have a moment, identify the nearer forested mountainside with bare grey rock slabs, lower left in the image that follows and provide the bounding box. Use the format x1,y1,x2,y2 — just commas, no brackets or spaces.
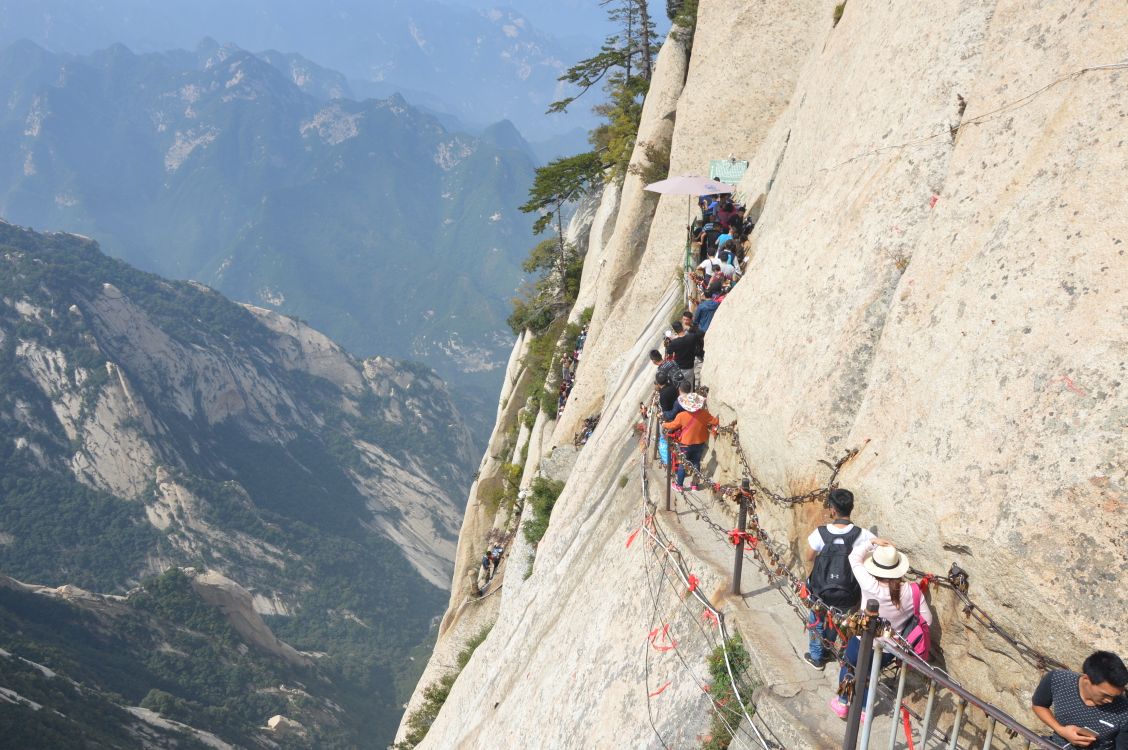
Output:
0,223,470,747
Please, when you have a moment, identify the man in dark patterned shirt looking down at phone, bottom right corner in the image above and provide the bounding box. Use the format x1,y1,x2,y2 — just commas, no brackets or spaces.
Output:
1030,651,1128,750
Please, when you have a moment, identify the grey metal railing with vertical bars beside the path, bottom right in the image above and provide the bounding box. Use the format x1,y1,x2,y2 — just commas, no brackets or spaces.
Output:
843,618,1060,750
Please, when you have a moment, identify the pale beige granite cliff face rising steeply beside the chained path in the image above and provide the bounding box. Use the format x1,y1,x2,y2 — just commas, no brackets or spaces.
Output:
401,0,1128,748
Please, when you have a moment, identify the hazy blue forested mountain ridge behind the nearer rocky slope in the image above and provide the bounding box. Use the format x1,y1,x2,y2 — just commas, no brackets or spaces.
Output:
0,42,534,435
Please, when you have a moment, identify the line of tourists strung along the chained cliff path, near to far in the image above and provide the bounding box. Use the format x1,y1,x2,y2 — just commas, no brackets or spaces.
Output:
650,188,1128,750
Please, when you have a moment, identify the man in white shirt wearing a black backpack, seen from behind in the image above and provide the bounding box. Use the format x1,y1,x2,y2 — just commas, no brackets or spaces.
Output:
803,488,874,671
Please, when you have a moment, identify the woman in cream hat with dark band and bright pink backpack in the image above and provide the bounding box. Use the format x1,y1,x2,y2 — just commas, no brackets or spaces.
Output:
830,539,932,718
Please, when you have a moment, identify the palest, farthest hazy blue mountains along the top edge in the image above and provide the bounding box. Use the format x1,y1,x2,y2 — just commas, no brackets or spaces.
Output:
0,0,618,136
